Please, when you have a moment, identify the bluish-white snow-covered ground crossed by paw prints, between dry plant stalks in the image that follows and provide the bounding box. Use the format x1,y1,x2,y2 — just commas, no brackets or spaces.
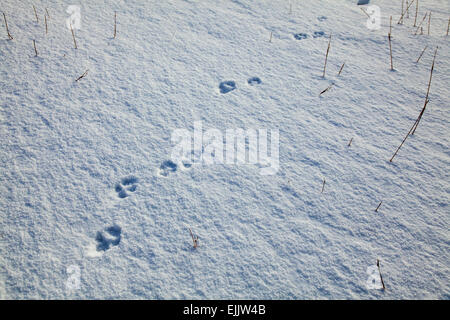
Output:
0,0,450,299
